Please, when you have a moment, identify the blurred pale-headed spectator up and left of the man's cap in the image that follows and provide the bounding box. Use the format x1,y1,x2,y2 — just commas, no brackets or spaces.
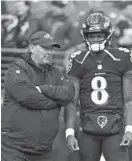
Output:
15,1,39,48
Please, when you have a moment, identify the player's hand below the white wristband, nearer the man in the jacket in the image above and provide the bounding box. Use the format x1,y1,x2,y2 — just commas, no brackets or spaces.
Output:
67,135,79,151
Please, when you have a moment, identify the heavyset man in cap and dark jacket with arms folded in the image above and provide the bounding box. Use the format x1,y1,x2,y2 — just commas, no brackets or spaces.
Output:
1,31,74,161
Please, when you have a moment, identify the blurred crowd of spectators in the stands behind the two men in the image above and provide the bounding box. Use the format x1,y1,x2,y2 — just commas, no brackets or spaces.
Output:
1,0,132,50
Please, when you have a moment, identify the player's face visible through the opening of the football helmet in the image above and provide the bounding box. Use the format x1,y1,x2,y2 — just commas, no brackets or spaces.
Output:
88,32,106,44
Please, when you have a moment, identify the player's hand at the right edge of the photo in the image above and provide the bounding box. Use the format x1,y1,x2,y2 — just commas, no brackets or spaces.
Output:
120,131,132,146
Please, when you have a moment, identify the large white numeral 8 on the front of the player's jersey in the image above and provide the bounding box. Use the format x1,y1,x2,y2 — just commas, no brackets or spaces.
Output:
91,76,109,105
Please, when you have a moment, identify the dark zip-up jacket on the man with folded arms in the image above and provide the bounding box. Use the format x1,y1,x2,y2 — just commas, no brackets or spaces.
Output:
2,54,74,154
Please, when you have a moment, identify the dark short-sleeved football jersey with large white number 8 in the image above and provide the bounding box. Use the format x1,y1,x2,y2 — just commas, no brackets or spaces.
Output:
67,48,132,112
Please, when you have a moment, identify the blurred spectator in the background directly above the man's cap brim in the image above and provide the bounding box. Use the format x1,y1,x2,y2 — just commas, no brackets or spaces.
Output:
40,1,73,50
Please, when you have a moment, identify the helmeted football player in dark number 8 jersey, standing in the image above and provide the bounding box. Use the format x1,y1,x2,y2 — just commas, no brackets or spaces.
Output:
65,13,132,161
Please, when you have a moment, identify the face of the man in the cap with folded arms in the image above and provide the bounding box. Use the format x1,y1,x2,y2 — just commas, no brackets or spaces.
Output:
30,45,53,65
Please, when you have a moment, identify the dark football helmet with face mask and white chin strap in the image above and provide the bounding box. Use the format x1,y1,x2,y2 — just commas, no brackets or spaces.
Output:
81,13,114,52
